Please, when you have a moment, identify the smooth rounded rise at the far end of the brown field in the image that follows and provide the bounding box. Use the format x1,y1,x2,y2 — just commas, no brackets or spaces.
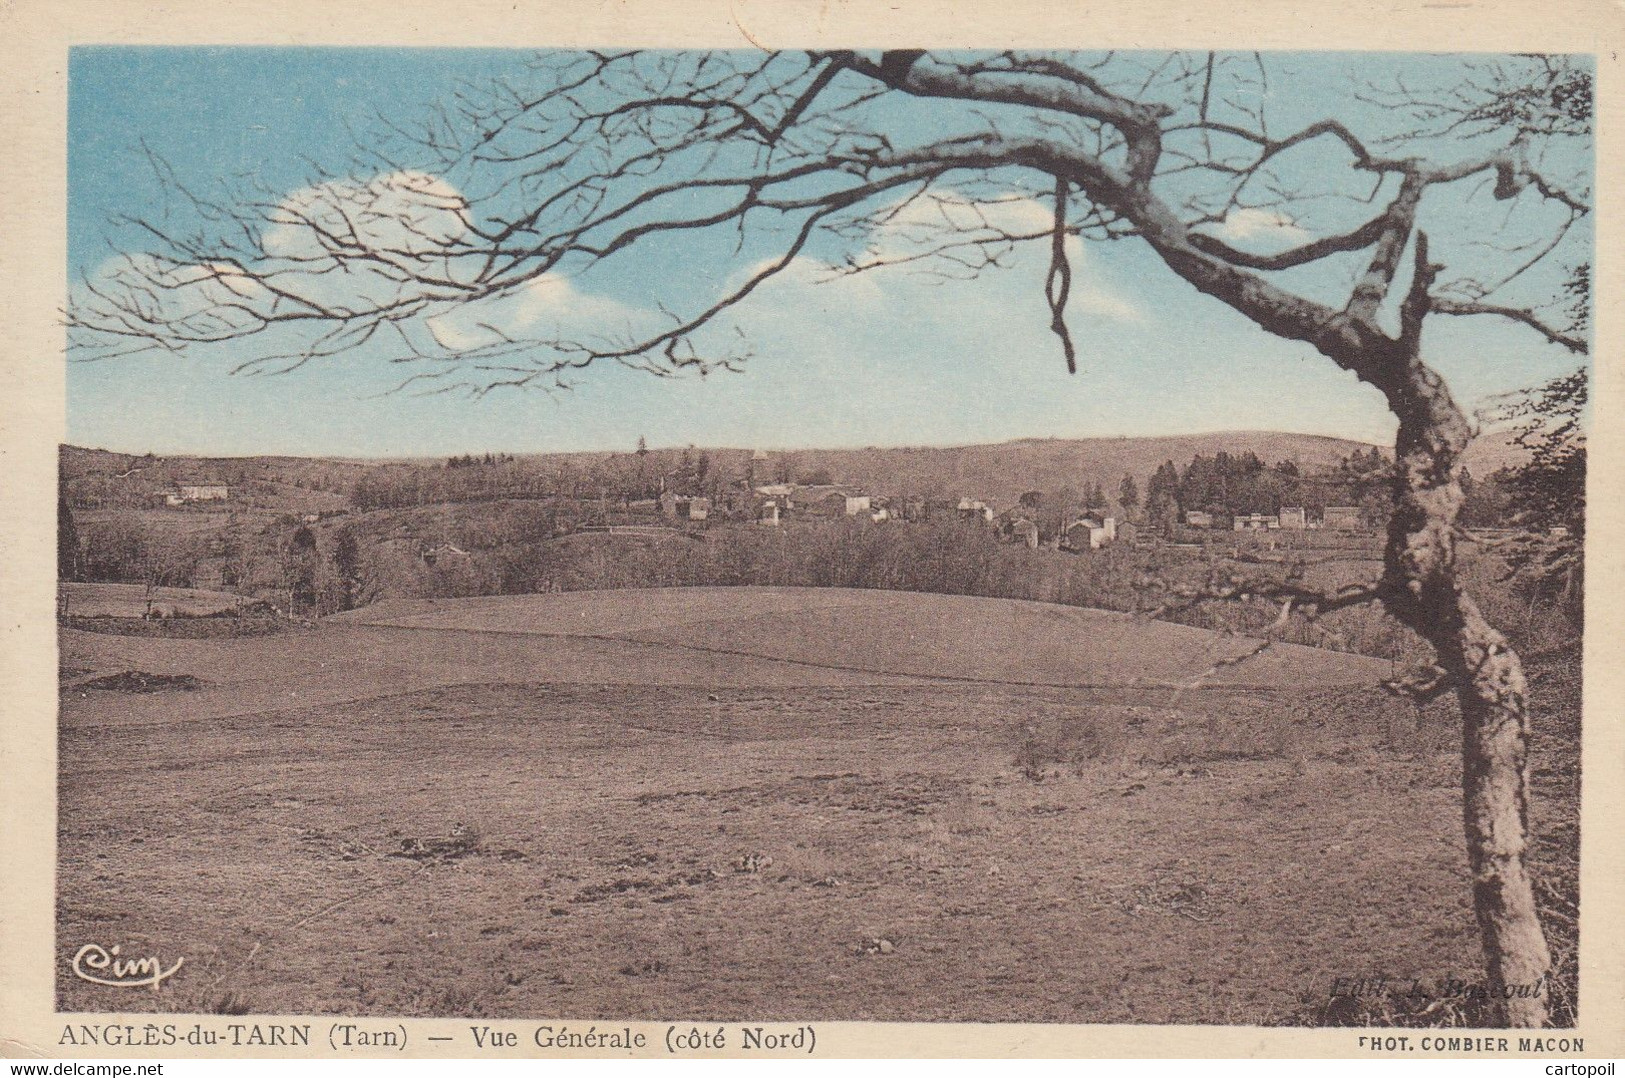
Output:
335,587,1393,686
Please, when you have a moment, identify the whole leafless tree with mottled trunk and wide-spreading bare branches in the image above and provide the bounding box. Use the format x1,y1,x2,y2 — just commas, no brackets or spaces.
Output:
67,49,1591,1024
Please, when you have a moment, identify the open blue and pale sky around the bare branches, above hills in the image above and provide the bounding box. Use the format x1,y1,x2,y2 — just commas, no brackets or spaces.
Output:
68,47,1589,455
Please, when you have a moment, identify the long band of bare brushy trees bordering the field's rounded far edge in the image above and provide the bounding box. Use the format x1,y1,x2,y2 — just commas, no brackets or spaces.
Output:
386,512,1571,660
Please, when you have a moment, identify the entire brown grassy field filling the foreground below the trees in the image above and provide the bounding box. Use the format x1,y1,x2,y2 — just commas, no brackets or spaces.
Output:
57,589,1578,1023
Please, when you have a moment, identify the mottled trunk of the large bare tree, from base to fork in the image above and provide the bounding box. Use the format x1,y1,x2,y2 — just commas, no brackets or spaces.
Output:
1385,363,1552,1028
